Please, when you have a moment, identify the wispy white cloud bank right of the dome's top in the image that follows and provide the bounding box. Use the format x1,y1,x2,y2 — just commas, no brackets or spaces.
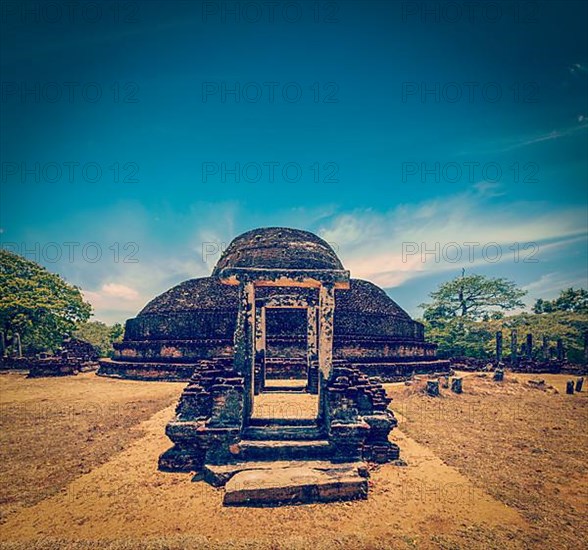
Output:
319,189,586,287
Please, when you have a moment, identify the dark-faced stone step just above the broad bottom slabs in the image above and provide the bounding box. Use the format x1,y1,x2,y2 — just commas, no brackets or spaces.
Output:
235,439,331,461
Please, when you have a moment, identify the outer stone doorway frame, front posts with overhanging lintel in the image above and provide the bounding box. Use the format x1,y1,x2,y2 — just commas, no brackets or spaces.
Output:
219,268,349,426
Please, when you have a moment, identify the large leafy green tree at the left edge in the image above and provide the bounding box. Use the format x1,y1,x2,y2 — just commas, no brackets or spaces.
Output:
0,250,92,353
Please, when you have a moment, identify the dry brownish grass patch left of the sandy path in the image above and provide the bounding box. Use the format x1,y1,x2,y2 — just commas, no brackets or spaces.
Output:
0,373,183,523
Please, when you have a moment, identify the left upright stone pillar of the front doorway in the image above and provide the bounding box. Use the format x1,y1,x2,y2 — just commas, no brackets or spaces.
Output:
234,282,255,419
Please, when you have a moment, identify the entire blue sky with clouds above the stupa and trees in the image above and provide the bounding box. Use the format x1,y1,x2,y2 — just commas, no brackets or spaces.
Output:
0,1,588,322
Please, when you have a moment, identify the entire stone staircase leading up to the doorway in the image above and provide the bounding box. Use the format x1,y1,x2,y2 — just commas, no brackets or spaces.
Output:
204,418,368,506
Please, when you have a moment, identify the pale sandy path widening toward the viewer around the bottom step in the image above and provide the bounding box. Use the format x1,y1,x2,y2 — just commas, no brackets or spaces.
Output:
0,406,526,548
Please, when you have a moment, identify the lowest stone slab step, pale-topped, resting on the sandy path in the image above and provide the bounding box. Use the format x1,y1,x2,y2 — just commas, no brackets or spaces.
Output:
223,463,368,506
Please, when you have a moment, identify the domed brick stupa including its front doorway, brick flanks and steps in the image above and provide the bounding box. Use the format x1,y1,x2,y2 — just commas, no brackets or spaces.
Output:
100,228,448,505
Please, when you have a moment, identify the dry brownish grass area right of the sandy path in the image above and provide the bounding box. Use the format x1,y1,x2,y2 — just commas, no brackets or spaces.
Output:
389,374,588,548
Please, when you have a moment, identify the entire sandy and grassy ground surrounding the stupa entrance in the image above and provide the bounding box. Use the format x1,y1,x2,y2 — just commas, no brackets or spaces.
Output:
0,374,588,549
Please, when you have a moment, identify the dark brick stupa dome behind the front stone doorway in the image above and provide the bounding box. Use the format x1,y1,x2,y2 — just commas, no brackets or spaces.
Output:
99,228,449,385
